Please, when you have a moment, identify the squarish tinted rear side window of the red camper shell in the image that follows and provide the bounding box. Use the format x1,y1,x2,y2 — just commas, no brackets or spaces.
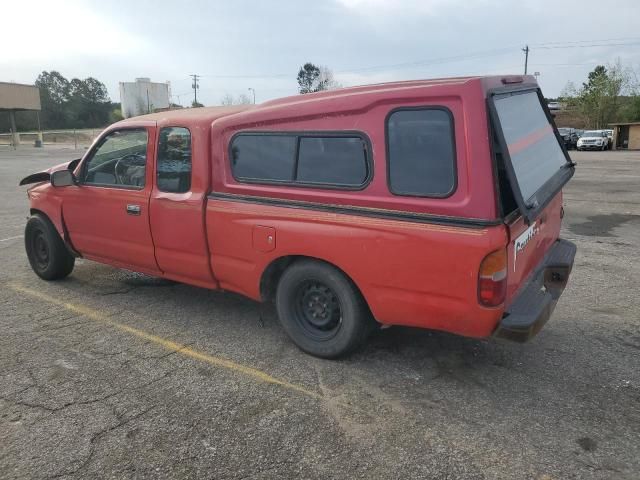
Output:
386,108,456,197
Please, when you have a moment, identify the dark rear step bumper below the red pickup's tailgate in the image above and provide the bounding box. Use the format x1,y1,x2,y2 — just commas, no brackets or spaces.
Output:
494,239,576,342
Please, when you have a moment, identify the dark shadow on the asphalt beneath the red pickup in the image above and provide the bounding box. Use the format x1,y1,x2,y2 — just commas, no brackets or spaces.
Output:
57,263,531,387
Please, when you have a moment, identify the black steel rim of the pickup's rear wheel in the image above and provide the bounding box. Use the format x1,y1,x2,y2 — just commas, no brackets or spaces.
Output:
295,280,342,340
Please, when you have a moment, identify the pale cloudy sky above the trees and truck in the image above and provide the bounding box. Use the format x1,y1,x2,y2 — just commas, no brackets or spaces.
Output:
0,0,640,105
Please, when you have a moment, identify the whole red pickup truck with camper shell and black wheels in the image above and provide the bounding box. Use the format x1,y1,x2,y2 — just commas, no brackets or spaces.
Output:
21,76,576,358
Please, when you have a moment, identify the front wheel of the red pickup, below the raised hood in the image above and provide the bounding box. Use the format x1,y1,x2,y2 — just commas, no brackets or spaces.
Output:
24,213,76,280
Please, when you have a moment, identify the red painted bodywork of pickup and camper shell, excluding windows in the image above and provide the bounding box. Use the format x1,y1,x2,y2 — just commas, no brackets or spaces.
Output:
25,77,561,337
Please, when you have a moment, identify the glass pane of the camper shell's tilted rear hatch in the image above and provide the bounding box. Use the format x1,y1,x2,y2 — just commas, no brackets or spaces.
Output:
495,91,567,203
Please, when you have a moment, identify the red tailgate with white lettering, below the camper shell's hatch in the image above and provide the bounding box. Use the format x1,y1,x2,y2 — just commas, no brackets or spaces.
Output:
505,193,562,307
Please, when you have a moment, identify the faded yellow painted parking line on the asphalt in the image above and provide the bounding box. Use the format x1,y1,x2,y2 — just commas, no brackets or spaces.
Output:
8,283,322,399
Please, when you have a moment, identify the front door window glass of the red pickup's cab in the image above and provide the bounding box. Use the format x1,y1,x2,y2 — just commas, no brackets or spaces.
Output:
82,128,148,188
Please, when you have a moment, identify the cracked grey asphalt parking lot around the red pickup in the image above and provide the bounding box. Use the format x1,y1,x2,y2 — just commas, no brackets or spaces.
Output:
0,147,640,480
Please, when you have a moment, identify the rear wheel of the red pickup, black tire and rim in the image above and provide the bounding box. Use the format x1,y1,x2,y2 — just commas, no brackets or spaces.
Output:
276,260,375,358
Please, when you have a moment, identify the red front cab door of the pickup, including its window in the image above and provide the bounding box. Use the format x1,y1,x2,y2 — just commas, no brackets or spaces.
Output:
62,122,159,274
